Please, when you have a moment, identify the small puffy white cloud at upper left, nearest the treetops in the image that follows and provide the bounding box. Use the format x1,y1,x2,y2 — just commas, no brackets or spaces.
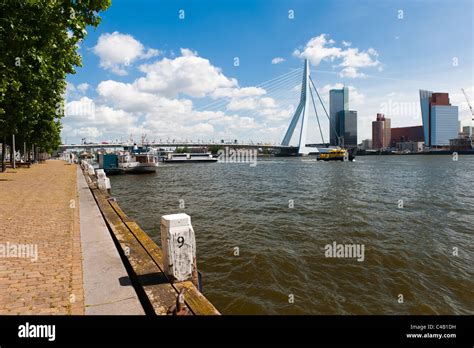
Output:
93,31,160,75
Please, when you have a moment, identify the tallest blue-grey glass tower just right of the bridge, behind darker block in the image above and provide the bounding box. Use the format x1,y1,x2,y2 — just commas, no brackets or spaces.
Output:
329,87,349,146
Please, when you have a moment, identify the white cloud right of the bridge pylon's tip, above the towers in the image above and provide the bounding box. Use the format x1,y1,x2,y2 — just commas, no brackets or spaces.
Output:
293,34,381,78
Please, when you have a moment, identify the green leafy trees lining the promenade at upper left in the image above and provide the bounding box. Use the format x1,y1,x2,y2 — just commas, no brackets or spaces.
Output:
0,0,110,171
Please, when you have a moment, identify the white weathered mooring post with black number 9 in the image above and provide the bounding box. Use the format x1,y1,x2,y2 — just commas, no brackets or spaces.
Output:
161,213,198,287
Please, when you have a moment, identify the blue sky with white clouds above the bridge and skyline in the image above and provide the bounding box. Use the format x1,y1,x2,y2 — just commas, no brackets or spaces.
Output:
62,0,474,144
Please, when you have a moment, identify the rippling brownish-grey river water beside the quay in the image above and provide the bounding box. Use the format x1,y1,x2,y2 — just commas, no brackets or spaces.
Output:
111,156,474,314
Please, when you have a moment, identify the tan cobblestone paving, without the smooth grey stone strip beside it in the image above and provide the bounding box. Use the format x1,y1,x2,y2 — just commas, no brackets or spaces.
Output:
0,160,84,314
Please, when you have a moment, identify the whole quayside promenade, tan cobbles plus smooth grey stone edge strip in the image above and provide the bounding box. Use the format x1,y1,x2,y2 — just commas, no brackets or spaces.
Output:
0,160,144,315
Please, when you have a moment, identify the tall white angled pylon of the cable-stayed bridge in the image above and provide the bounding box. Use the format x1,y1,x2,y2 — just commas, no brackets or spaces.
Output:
281,59,318,155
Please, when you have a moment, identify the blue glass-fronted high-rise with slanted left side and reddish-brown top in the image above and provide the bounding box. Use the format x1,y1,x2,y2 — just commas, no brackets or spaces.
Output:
420,90,459,146
